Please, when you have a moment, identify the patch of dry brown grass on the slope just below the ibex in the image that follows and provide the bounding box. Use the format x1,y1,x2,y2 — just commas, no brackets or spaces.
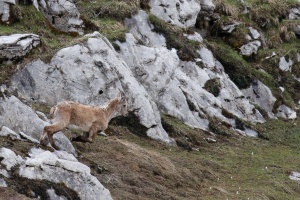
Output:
73,126,220,199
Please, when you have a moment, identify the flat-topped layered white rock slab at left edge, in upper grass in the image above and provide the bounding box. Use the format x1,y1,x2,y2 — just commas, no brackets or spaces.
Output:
0,34,41,63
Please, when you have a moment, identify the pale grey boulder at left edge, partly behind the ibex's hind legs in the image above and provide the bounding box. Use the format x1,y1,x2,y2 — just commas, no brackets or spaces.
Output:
0,96,76,155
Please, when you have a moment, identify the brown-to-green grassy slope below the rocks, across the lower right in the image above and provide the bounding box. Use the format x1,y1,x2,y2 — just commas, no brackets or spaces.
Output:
0,116,300,199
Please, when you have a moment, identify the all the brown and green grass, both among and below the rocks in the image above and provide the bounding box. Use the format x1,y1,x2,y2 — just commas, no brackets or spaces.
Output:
0,0,300,199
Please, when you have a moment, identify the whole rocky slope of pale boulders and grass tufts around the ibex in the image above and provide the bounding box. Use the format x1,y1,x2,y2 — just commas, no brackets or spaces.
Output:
0,0,300,199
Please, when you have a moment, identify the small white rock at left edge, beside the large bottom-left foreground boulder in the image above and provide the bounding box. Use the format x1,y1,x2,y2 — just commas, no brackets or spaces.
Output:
0,148,24,170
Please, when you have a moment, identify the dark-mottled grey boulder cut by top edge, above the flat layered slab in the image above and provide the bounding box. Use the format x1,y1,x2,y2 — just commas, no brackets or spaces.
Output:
34,0,84,34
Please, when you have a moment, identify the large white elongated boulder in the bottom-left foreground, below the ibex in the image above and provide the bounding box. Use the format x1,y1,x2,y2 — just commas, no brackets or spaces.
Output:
19,148,112,200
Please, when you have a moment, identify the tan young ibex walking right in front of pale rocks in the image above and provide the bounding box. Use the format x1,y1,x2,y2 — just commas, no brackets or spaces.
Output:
40,91,127,150
